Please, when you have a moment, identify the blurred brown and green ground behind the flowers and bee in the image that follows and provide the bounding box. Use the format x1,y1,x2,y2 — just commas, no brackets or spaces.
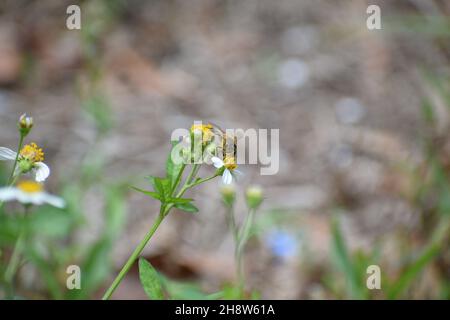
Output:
0,0,450,299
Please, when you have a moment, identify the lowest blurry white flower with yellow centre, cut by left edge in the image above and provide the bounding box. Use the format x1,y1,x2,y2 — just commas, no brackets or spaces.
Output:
0,181,66,208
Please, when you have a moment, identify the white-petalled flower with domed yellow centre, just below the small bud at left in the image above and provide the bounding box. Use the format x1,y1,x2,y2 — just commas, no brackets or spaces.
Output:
0,143,50,182
